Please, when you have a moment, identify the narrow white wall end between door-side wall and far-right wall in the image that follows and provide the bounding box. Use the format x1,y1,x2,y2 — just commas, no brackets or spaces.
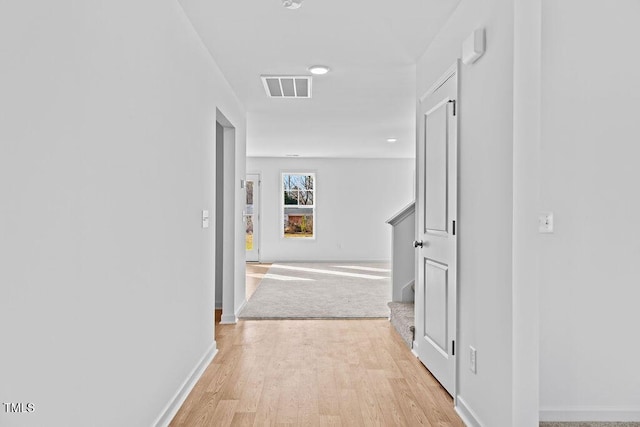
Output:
511,0,542,427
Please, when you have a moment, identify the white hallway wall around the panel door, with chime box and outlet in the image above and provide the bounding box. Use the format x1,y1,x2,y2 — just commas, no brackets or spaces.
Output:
417,0,513,427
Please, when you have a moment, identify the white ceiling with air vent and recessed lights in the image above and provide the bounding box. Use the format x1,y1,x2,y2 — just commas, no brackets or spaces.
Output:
181,0,460,158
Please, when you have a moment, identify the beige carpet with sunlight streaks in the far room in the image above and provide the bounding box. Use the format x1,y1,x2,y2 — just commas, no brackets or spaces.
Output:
239,263,391,319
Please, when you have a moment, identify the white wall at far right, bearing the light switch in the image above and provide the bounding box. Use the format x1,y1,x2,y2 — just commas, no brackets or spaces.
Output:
540,0,640,421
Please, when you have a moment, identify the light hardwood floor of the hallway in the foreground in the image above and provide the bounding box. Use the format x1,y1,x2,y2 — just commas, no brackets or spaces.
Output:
171,266,463,427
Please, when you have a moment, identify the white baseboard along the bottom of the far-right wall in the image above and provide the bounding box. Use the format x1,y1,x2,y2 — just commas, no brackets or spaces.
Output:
540,406,640,422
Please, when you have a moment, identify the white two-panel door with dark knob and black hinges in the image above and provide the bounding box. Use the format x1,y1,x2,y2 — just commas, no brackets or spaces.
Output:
414,64,458,396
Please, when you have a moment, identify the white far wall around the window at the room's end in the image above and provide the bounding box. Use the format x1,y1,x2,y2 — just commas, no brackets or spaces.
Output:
247,157,415,262
